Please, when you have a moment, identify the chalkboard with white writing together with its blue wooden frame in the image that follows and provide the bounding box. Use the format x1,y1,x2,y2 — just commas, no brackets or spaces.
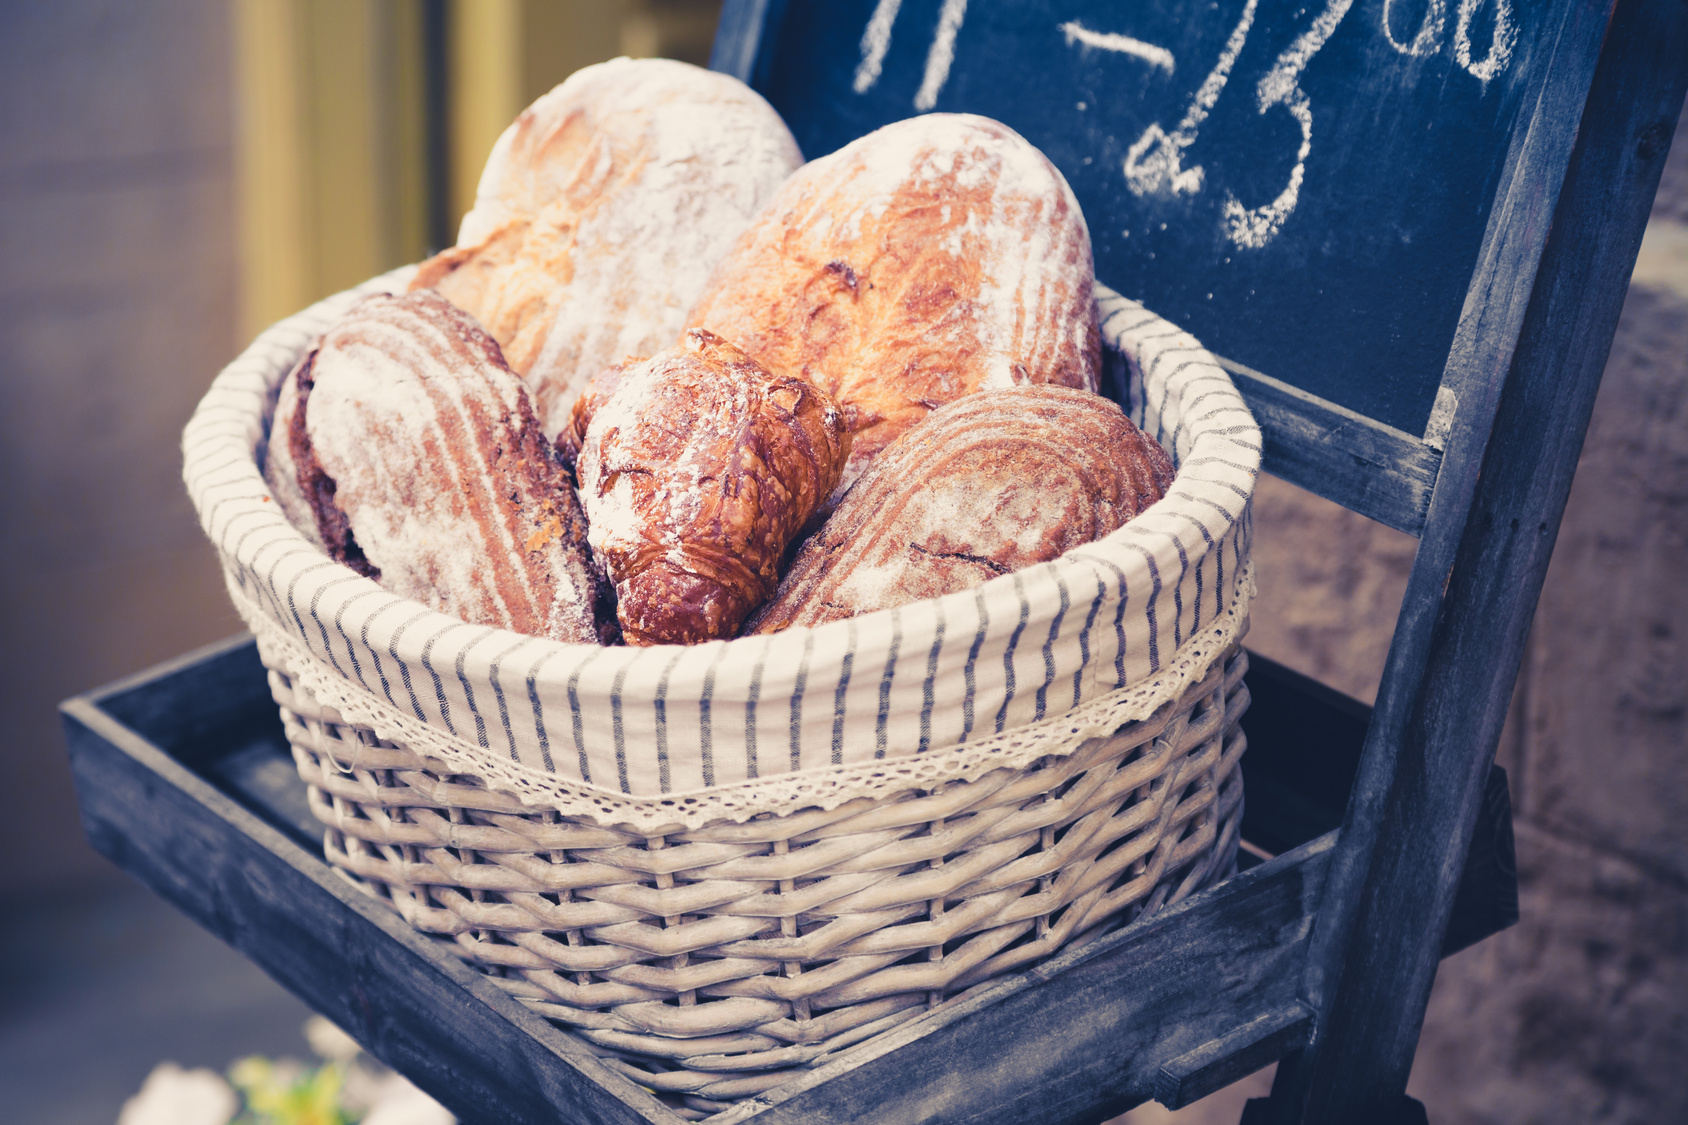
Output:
705,0,1688,1122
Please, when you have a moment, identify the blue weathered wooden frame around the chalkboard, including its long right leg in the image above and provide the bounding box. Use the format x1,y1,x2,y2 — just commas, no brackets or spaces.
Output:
712,0,1688,1125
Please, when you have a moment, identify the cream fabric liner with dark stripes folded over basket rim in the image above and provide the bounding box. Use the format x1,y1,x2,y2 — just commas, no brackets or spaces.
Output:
184,267,1261,814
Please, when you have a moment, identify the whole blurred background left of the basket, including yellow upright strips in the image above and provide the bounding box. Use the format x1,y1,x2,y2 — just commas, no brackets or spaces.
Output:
0,0,719,890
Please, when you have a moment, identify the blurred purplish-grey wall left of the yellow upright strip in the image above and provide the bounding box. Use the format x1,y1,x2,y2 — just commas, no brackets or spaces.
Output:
0,0,240,894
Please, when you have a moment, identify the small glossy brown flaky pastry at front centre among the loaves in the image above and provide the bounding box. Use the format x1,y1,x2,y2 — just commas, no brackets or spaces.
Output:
577,329,849,645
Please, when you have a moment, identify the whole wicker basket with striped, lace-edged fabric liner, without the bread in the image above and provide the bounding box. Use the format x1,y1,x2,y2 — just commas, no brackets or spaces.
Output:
182,270,1261,1117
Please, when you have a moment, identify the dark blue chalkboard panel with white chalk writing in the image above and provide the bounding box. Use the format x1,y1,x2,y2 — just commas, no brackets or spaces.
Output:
716,0,1558,530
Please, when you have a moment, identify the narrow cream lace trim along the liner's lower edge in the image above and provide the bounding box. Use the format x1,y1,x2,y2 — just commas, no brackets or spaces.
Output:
228,563,1258,836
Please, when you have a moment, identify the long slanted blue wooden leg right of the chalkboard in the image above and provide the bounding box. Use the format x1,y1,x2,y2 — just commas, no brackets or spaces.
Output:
1246,0,1688,1125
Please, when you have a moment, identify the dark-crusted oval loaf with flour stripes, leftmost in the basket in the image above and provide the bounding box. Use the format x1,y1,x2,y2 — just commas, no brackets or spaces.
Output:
288,292,613,644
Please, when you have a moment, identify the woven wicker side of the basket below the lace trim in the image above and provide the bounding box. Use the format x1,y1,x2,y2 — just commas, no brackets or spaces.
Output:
270,635,1247,1117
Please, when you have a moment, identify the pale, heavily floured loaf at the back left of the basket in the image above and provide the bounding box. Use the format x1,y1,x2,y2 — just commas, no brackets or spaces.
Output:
410,59,802,436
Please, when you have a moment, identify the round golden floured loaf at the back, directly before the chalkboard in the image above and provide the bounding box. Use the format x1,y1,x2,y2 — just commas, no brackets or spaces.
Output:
689,113,1101,500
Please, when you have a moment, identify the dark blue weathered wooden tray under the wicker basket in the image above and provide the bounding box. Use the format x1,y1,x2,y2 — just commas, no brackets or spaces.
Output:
61,637,1518,1125
